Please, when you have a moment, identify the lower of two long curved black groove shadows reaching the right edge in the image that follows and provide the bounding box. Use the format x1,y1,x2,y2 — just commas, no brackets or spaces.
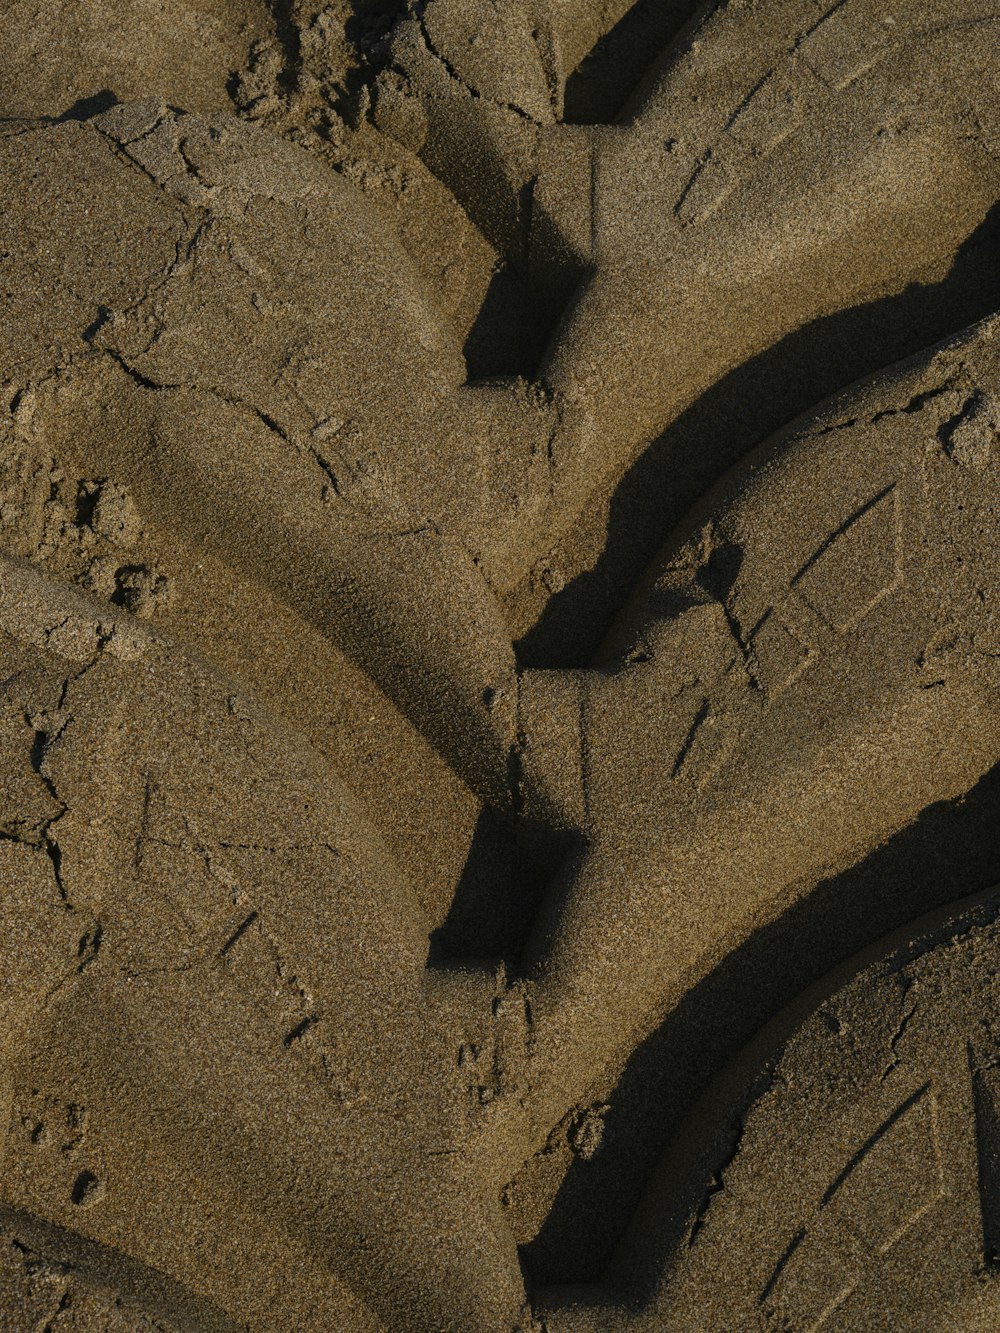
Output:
515,764,1000,1286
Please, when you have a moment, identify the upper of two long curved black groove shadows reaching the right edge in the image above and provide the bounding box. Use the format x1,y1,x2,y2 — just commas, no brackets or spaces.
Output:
516,205,1000,668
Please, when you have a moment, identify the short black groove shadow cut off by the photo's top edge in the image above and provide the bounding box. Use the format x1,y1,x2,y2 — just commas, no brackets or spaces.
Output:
563,0,704,125
